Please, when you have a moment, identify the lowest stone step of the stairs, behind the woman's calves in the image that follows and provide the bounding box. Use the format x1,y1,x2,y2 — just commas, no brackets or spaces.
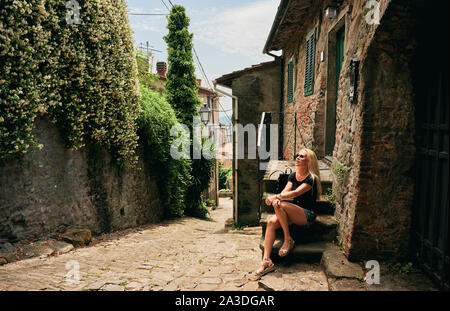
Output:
259,237,332,262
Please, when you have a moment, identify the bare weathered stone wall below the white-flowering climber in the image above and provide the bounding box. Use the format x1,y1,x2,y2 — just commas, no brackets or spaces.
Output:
0,119,164,242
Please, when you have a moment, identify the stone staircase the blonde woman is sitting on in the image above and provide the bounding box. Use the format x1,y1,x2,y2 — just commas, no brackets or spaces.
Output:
260,161,338,262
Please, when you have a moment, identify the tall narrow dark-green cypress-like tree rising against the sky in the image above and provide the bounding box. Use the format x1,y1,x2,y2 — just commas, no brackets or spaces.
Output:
164,5,215,217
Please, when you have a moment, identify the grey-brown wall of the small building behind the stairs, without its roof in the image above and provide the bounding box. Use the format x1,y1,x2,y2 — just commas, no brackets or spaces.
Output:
232,62,281,225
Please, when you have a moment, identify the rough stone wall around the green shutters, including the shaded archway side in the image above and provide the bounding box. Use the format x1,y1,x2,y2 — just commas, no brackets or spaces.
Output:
283,0,415,259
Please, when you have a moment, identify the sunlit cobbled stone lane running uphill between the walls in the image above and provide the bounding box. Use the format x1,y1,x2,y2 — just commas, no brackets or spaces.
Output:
0,198,328,291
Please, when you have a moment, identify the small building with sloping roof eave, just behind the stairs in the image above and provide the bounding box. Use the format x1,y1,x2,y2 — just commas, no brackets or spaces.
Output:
215,61,281,226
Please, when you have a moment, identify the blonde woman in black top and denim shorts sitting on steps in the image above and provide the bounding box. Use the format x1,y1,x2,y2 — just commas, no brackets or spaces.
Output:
255,149,322,276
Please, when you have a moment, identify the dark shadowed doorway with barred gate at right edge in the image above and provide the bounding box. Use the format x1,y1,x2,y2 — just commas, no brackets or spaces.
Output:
412,1,449,291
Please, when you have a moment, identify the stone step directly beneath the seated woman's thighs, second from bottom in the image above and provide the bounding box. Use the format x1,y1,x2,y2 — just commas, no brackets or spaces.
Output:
260,213,338,244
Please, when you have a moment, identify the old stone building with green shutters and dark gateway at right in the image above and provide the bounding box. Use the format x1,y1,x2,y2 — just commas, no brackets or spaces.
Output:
220,0,448,289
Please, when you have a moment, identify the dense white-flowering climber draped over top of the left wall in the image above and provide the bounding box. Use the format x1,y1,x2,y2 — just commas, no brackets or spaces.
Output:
0,0,140,163
